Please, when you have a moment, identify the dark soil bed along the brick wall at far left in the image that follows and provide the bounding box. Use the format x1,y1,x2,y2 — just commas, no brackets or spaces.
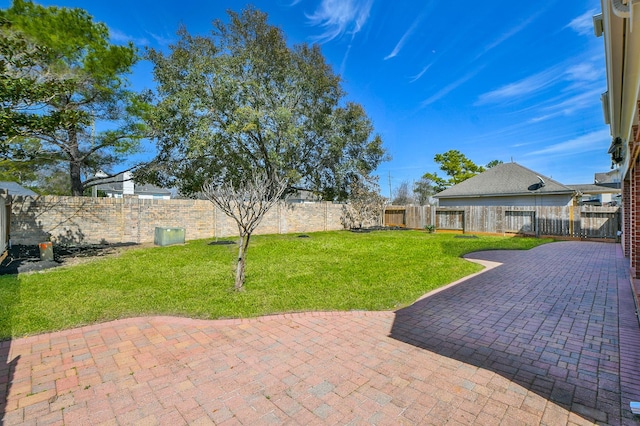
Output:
0,243,138,275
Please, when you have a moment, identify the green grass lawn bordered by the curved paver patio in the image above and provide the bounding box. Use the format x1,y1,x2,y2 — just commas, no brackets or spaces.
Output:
0,231,550,340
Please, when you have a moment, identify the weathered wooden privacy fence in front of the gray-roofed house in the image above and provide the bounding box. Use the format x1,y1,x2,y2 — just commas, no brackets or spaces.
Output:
384,206,620,238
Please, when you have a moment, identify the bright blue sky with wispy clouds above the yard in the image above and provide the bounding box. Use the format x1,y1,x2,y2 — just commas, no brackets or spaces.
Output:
0,0,611,195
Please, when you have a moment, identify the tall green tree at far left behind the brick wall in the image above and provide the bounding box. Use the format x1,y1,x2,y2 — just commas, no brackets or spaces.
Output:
0,0,144,195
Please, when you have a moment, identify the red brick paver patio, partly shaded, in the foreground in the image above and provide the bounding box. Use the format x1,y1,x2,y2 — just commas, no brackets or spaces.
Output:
0,242,640,426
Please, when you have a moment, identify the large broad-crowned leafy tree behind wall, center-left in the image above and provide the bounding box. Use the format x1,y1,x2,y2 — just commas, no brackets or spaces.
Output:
144,8,385,199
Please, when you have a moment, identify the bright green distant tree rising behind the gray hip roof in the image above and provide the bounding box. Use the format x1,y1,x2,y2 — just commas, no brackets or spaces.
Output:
422,149,502,192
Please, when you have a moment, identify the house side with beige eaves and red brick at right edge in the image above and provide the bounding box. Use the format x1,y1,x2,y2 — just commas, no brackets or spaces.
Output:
593,0,640,280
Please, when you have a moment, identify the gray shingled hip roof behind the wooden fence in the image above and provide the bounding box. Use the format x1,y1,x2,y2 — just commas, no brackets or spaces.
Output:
434,163,575,198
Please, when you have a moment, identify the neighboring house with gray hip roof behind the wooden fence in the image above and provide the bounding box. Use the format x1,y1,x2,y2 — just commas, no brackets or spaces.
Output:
434,163,576,207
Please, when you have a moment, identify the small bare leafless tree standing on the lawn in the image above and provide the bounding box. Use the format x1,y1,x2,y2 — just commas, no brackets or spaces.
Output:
202,172,287,291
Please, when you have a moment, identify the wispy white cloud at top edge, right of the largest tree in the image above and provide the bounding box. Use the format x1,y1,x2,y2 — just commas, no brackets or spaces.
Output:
307,0,373,43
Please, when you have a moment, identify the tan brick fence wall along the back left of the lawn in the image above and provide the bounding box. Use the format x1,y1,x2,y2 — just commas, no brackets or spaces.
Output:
10,196,343,245
